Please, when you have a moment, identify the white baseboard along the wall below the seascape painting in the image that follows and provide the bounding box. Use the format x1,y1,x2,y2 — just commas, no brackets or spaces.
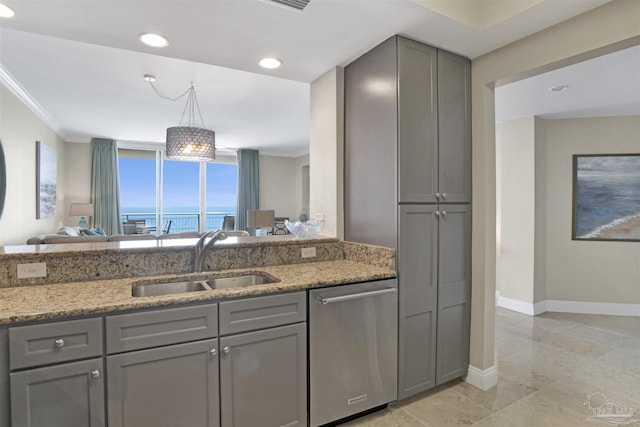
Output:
496,291,640,317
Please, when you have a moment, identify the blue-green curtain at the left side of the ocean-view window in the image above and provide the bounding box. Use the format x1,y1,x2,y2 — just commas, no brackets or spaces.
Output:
91,138,122,235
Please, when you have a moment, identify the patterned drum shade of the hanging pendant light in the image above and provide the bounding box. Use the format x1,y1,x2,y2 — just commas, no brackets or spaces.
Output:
166,126,216,161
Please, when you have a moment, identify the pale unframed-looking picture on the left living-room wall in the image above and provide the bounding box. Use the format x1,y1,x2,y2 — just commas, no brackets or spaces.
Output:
36,141,58,219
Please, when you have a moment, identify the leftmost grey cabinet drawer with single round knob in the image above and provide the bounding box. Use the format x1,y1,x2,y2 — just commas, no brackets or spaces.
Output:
9,318,102,369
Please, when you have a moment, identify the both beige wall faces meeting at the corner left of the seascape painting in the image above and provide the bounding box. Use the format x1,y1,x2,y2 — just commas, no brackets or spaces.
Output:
496,116,640,304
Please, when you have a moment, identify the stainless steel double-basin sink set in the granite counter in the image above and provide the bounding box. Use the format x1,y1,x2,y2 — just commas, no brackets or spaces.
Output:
131,272,279,297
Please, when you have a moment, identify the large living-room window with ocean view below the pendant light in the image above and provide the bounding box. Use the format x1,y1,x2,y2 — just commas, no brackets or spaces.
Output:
118,149,238,234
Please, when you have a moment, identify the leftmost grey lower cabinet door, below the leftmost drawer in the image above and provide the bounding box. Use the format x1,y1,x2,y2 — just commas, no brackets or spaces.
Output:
10,358,105,427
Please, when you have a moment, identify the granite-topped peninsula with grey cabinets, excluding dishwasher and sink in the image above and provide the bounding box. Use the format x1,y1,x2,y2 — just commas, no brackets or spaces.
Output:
0,236,396,427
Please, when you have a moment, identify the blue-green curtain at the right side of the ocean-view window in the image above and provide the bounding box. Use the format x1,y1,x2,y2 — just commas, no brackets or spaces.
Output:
235,150,260,236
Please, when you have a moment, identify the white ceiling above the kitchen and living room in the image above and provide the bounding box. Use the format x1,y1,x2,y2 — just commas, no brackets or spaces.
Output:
0,0,632,156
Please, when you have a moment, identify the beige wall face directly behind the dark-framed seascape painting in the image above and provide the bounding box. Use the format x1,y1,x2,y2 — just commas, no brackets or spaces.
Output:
545,116,640,304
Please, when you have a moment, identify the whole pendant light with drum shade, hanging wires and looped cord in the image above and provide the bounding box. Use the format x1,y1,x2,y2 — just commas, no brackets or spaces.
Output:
144,75,216,162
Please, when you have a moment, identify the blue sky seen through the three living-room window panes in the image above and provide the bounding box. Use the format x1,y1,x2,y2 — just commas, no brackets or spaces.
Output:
119,157,237,212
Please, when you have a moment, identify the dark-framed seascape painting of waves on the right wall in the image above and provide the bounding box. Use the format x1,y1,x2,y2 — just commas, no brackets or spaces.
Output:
572,153,640,242
